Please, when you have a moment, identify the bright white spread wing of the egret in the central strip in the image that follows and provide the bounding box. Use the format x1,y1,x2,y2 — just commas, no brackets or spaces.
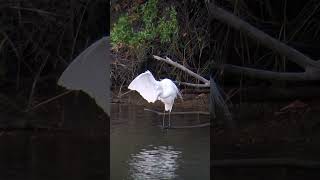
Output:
128,71,159,103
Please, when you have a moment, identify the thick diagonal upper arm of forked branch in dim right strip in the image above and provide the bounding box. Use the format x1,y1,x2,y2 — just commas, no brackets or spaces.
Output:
209,3,320,68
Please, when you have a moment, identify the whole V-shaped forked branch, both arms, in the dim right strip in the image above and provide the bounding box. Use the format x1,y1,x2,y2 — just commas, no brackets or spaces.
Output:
209,3,320,81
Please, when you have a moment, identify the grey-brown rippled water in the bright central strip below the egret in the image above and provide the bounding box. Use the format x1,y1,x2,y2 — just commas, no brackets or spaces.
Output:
110,104,210,180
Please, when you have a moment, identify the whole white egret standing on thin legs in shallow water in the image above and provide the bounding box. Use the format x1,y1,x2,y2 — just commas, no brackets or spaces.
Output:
128,70,182,127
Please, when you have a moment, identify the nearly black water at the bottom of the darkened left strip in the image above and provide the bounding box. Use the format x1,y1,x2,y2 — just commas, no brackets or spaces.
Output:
0,94,110,180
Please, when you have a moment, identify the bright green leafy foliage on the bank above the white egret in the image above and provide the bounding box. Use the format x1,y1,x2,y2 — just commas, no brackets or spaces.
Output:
111,0,178,53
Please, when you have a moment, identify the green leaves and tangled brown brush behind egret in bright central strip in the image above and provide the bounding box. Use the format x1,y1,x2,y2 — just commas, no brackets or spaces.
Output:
111,0,210,85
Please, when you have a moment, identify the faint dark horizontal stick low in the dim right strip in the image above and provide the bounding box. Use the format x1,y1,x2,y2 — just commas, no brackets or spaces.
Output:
212,158,320,168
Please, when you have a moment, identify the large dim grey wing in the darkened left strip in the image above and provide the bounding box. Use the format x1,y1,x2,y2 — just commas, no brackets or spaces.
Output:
58,37,111,115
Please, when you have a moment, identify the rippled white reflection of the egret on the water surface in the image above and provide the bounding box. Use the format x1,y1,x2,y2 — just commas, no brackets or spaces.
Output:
128,146,181,180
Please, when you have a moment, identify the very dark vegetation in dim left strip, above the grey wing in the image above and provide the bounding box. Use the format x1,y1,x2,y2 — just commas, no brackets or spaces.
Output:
0,0,109,111
